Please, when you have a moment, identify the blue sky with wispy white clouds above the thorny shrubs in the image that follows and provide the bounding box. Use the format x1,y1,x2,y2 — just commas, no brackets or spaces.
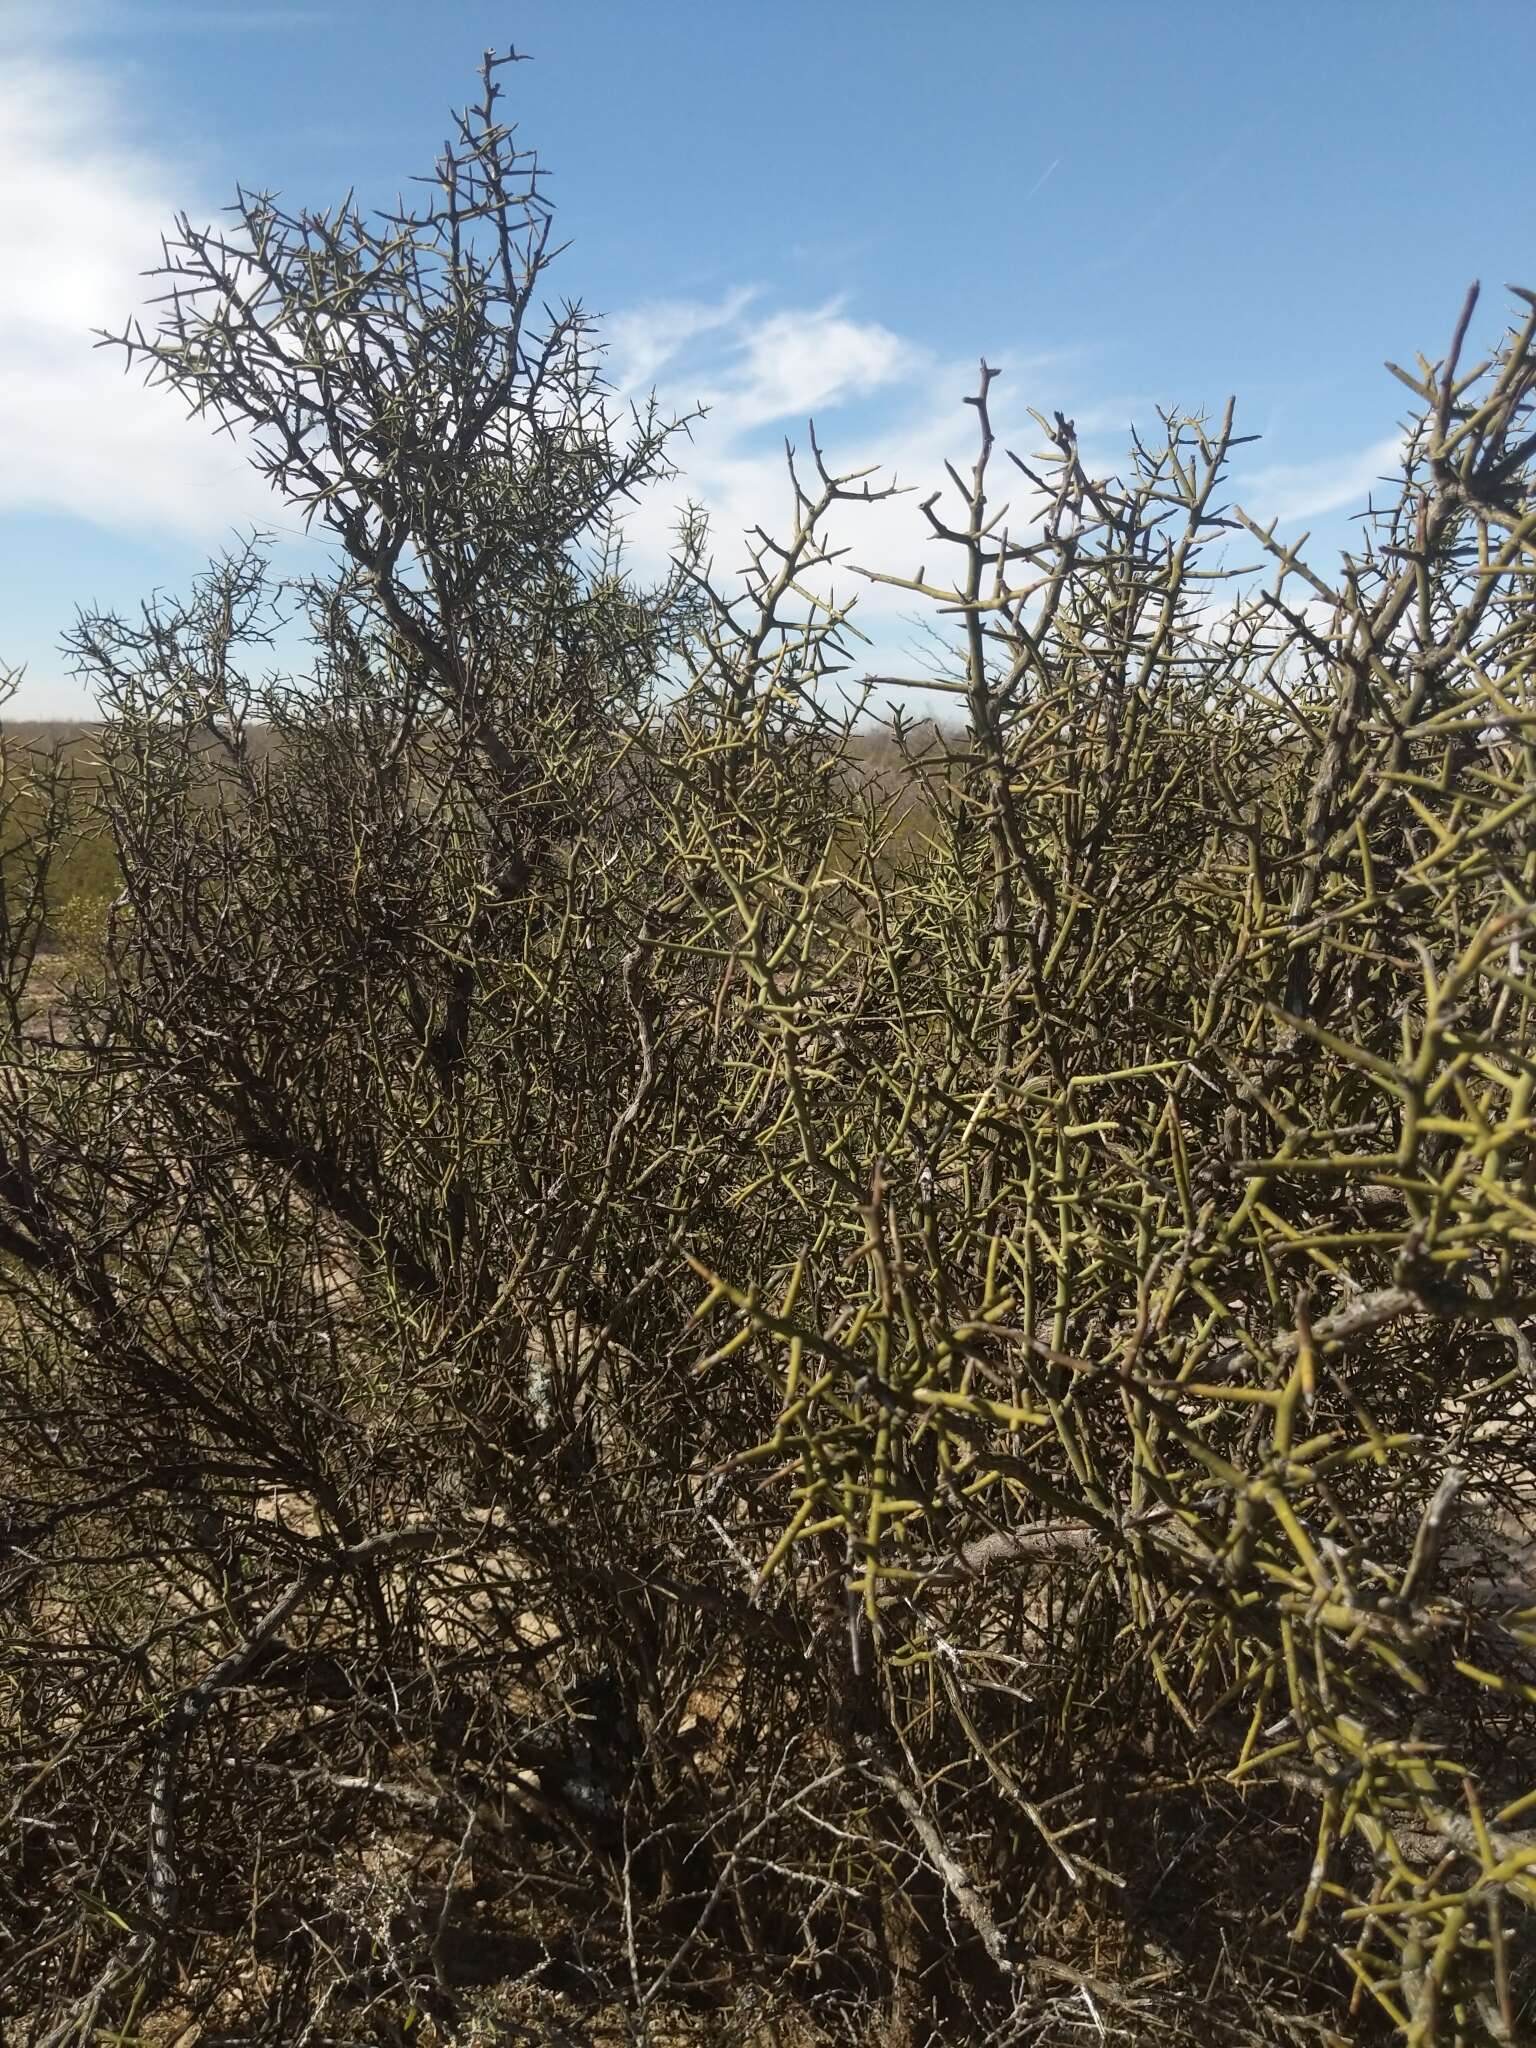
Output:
0,0,1536,715
